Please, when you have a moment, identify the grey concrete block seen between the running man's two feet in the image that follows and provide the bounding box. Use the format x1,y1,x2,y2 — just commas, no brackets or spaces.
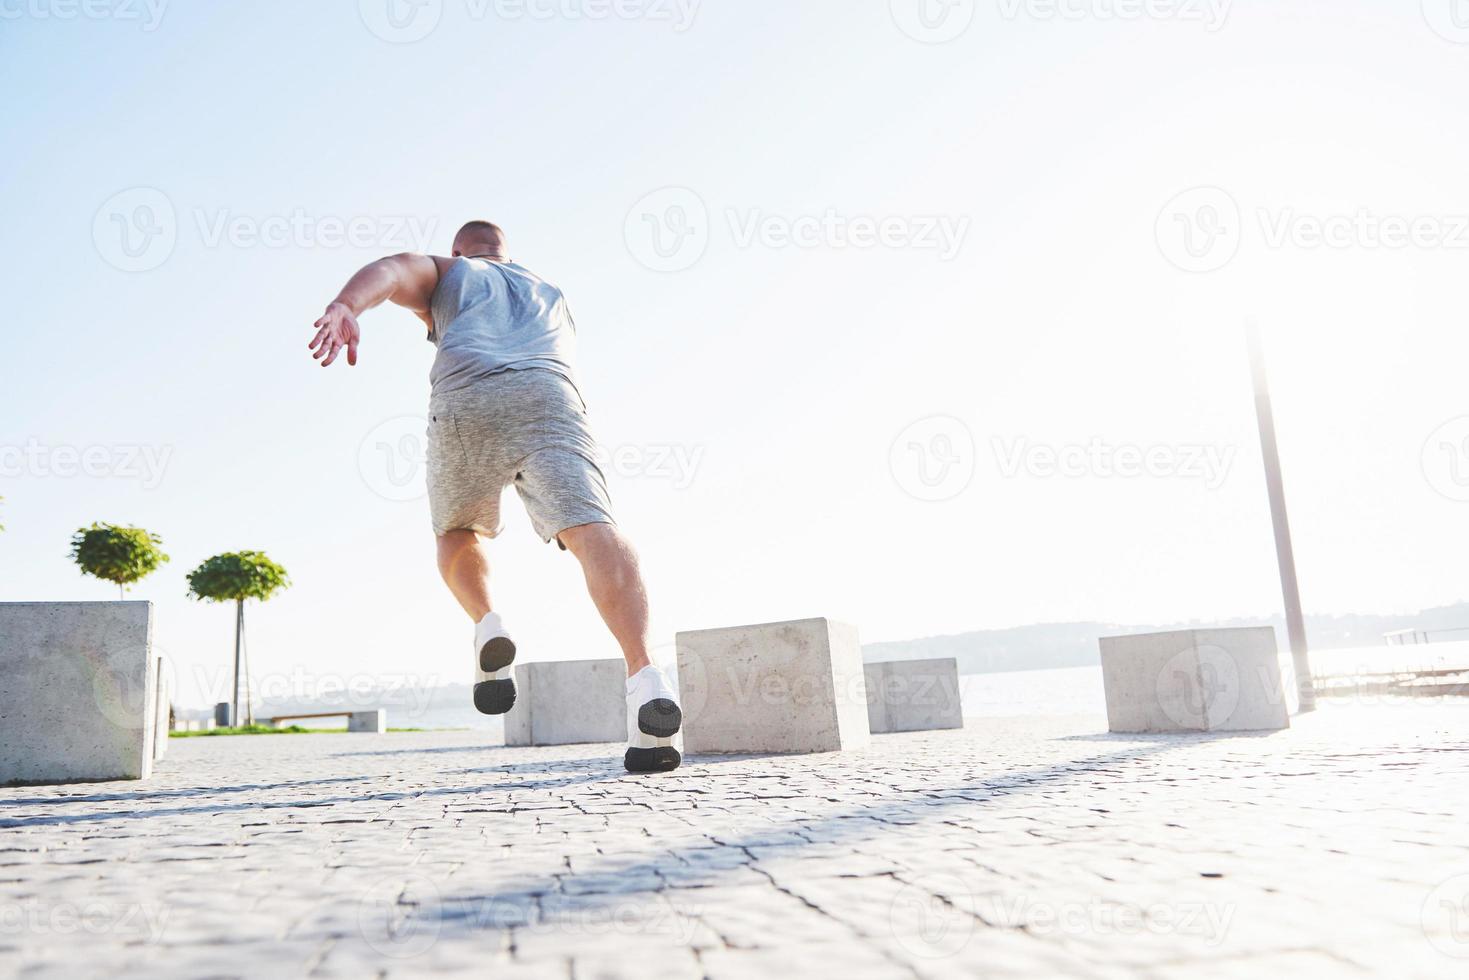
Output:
505,658,627,745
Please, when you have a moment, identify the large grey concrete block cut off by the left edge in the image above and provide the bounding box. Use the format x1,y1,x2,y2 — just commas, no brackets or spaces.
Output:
0,602,157,785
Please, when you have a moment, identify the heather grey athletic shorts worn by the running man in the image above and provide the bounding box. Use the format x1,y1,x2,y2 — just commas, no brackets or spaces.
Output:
429,367,614,541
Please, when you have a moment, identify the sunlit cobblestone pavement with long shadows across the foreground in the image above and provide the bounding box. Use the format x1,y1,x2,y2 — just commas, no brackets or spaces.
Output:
0,704,1469,979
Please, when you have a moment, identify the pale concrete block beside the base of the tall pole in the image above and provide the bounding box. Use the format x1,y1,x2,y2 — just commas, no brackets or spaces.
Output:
1102,626,1290,732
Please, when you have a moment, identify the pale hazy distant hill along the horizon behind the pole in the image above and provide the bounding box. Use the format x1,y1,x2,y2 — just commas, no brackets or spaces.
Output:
862,602,1469,674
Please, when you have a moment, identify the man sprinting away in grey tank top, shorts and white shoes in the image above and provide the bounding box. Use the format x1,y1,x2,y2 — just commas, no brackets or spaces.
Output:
310,220,683,773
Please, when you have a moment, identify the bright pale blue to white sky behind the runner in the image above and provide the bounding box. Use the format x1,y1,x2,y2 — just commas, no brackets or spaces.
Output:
0,0,1469,704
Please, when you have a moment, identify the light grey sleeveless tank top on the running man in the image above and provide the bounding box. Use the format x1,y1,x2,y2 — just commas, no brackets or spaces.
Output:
429,257,576,392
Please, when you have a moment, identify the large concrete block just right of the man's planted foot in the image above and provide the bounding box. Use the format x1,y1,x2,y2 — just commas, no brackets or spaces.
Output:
677,619,868,752
